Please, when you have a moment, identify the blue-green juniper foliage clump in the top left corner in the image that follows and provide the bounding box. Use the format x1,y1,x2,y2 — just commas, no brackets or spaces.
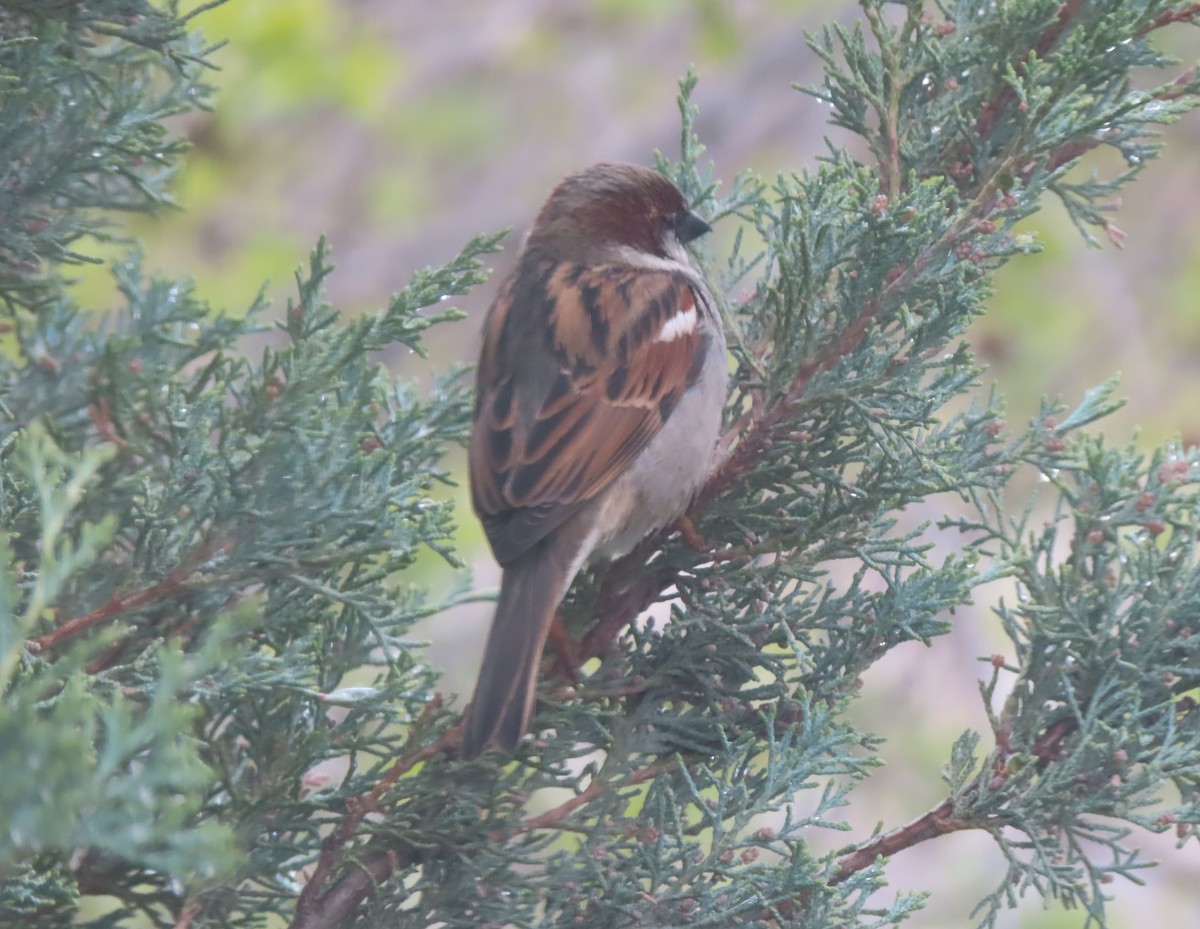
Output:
0,1,224,312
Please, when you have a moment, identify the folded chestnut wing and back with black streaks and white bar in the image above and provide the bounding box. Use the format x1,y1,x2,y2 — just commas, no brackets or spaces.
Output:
470,265,707,564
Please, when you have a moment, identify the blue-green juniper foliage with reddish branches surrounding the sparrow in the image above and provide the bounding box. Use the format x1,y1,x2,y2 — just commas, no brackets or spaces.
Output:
0,0,1200,929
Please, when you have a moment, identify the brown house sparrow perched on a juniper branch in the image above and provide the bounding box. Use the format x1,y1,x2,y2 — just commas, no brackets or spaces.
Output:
461,162,727,759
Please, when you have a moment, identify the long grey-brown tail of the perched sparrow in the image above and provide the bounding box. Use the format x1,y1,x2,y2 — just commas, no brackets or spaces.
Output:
460,543,571,759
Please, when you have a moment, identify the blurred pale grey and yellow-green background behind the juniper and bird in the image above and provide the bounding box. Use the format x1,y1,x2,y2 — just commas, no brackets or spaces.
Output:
72,0,1200,929
